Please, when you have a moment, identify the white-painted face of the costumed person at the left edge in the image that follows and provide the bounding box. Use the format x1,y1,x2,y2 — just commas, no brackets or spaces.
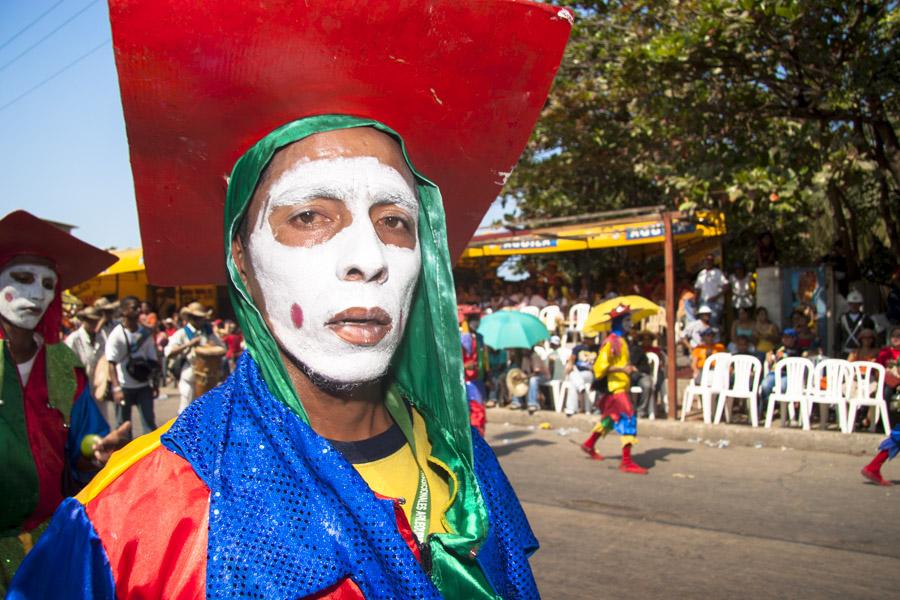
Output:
0,263,57,329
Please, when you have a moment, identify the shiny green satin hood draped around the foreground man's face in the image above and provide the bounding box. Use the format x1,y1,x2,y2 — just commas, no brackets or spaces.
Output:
225,115,496,598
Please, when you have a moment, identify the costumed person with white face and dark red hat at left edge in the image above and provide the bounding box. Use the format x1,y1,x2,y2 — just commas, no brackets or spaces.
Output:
0,210,131,593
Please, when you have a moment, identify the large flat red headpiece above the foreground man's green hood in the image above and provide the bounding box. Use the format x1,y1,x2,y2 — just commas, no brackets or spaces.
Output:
110,0,572,285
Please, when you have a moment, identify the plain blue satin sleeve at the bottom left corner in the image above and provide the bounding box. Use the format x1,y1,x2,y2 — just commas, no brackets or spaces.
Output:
6,498,116,600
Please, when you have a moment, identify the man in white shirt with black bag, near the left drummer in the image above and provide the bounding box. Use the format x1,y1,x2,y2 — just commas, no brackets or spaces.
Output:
106,296,159,433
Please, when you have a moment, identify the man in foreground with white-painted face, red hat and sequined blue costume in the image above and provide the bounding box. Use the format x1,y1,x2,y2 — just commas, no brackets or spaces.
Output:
12,0,571,599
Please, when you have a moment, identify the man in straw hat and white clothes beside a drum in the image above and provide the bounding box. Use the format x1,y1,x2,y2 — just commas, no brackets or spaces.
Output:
165,302,225,414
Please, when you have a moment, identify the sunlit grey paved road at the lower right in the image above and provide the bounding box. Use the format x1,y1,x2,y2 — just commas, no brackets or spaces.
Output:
487,423,900,600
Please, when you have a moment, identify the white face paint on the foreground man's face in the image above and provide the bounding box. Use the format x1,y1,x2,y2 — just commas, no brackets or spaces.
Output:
248,157,421,384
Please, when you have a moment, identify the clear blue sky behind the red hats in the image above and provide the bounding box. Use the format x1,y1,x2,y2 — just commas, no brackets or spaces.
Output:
0,0,509,248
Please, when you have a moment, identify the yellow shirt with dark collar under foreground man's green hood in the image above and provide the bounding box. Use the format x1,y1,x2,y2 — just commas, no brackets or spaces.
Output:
353,410,452,534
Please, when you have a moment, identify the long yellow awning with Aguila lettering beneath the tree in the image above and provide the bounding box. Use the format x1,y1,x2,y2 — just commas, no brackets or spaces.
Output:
462,211,725,258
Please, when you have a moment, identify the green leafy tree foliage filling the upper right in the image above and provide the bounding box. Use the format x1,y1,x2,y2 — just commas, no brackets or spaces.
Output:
507,0,900,276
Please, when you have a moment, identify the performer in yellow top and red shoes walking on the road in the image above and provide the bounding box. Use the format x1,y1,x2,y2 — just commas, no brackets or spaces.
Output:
581,304,647,475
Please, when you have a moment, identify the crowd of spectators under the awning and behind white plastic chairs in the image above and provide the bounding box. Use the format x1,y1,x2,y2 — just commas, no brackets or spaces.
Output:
457,255,900,426
